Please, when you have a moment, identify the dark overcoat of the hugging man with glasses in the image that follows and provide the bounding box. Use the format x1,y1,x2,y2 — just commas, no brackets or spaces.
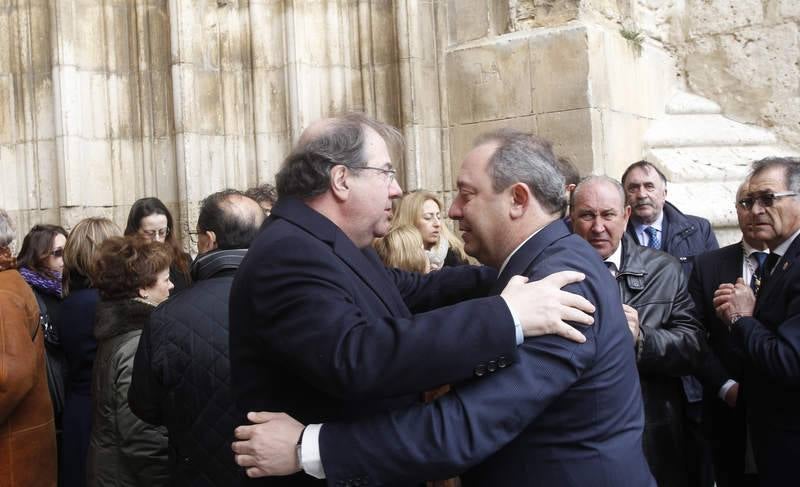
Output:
230,199,517,484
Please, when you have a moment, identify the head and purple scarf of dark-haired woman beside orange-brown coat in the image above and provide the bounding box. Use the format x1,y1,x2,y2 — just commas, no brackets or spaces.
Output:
17,225,67,323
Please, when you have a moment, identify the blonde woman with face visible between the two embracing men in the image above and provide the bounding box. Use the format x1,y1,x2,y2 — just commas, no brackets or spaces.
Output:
392,190,468,269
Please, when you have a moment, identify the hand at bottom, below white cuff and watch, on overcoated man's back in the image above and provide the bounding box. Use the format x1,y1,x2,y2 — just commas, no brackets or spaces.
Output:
231,412,303,477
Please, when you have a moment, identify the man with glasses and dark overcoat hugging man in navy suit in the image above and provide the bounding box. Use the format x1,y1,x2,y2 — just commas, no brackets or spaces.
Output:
229,114,593,485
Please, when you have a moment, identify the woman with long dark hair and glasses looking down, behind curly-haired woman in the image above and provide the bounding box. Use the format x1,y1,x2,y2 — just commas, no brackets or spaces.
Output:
125,198,192,293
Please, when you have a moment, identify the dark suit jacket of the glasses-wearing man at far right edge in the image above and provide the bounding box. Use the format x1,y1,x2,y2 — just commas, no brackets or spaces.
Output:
732,233,800,485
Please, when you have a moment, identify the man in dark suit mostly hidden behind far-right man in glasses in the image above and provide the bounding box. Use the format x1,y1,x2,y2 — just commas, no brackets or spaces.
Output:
689,181,769,487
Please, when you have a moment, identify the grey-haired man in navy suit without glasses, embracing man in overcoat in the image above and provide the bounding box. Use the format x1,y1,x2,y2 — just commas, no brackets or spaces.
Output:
234,130,655,487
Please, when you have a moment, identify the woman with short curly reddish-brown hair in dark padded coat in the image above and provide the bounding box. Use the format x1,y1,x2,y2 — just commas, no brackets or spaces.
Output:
87,237,173,487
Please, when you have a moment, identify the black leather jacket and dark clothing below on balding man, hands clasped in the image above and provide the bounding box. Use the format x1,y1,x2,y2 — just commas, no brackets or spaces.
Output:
616,233,701,487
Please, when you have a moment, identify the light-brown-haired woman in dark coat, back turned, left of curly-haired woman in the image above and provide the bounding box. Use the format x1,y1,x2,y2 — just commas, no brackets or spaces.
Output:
57,217,122,487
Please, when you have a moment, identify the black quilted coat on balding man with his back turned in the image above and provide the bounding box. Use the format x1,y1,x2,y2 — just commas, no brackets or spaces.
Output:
128,250,246,487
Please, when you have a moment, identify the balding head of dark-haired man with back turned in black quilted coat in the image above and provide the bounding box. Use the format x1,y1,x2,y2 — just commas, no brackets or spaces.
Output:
197,189,264,250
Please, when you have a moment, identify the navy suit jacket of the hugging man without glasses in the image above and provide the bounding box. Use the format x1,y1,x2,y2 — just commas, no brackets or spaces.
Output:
320,220,655,487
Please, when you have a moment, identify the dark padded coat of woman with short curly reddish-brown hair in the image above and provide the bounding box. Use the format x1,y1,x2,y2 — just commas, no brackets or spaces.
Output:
87,299,167,487
